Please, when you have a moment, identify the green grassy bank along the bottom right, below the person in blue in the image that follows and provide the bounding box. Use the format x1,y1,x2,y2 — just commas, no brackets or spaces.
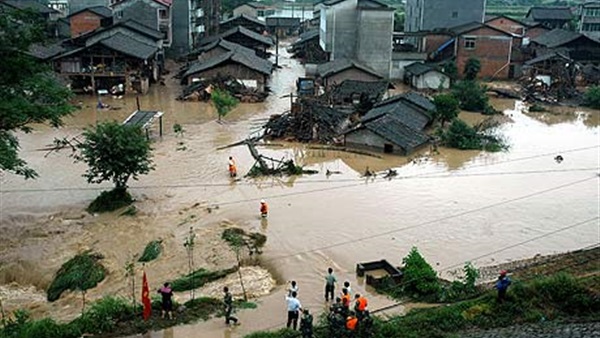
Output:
246,273,600,338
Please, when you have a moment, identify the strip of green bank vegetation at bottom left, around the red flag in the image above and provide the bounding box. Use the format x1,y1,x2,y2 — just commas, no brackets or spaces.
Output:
0,297,227,338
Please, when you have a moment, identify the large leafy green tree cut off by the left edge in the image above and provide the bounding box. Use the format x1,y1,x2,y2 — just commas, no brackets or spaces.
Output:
0,11,73,179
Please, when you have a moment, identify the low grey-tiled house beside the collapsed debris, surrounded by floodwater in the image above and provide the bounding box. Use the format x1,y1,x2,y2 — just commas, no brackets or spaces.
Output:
344,93,435,155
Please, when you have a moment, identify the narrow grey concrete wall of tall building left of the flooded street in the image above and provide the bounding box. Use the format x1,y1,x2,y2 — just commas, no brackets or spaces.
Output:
171,0,192,56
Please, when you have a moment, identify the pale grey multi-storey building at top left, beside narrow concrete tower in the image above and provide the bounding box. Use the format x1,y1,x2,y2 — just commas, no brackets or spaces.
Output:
111,0,173,47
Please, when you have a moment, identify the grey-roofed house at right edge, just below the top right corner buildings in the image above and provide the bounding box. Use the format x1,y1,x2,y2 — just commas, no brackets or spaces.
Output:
529,29,600,64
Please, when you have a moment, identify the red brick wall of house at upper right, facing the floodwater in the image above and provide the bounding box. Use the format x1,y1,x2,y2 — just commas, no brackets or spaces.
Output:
456,27,513,79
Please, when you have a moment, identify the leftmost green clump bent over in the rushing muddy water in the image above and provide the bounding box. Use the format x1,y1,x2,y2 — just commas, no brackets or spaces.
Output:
48,252,106,302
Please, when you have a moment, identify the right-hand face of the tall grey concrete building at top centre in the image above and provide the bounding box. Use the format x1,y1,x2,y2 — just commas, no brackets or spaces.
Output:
356,9,394,78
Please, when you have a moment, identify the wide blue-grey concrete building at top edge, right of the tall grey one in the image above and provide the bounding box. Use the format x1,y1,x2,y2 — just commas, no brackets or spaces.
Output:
404,0,486,32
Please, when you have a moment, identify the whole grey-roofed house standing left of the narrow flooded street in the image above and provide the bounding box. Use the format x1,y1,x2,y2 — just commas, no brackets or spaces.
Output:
182,50,273,92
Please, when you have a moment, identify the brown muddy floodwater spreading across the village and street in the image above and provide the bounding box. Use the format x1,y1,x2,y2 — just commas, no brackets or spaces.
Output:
0,48,600,337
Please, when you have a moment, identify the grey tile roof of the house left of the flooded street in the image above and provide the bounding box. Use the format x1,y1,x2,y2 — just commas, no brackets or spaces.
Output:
183,51,273,78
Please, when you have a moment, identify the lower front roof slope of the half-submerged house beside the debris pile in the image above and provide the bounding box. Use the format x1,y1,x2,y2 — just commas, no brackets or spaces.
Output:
363,115,429,150
